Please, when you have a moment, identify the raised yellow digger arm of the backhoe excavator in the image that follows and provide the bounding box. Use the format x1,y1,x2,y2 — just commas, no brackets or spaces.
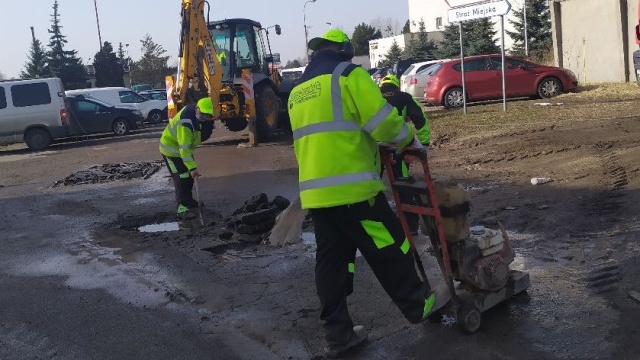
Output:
166,0,222,117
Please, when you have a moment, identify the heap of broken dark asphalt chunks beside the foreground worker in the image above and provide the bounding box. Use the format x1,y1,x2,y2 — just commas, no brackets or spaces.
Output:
225,193,291,242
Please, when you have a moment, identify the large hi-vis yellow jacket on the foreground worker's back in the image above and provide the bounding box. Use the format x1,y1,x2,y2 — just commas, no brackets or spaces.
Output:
288,51,414,209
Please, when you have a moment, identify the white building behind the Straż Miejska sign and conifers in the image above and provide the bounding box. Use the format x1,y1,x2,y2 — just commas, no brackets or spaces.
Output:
408,0,525,51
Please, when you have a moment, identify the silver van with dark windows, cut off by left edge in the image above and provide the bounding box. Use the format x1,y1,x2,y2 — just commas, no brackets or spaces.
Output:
0,78,71,151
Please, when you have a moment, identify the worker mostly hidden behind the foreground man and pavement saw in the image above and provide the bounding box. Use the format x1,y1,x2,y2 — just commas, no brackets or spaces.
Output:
380,75,431,235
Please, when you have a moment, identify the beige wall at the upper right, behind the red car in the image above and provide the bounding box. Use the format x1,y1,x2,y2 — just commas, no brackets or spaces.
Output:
551,0,638,84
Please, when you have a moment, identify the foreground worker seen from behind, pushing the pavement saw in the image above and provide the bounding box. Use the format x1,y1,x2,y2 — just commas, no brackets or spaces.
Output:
288,29,443,357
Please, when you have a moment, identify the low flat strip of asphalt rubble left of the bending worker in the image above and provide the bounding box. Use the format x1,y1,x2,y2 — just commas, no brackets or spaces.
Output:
52,161,162,187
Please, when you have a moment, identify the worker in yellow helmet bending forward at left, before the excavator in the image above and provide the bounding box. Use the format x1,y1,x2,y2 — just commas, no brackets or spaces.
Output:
160,97,214,220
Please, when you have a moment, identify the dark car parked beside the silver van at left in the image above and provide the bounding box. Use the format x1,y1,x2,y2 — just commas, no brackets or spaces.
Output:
66,95,144,135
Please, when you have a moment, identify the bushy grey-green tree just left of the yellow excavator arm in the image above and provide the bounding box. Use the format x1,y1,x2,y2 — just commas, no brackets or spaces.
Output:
131,34,172,87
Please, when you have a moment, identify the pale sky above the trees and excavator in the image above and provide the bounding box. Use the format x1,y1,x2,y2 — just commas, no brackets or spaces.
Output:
0,0,409,78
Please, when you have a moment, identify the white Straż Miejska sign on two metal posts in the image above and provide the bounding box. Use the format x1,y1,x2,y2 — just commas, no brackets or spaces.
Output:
445,0,511,115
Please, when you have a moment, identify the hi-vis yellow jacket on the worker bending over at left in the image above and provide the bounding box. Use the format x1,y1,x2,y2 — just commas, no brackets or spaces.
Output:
160,105,201,171
